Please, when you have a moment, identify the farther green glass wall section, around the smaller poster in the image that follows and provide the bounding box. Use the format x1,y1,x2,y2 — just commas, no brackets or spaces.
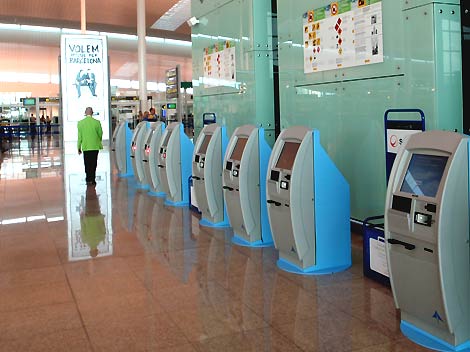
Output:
192,0,274,142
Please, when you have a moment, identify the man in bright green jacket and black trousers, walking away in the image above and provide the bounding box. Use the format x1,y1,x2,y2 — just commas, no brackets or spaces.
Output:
77,107,103,186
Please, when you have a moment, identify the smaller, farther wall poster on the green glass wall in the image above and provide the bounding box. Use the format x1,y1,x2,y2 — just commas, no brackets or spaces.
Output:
203,41,237,87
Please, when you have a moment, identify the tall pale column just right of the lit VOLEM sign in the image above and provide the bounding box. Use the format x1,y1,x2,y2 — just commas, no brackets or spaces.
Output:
137,0,148,112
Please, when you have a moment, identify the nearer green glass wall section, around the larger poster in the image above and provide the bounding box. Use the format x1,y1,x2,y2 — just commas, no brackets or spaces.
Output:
278,0,462,220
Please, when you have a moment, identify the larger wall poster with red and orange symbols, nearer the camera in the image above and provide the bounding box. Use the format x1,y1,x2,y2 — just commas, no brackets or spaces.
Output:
302,0,383,73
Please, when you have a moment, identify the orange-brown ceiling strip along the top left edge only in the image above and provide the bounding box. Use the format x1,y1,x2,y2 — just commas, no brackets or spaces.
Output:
0,0,191,40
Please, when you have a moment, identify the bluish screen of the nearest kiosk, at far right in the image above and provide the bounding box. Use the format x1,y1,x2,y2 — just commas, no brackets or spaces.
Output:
400,154,448,197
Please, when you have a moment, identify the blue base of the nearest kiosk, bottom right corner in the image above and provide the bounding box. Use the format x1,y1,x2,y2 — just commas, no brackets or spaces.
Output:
400,320,470,352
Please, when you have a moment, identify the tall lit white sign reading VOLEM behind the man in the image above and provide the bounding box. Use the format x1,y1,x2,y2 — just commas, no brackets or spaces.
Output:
60,35,109,142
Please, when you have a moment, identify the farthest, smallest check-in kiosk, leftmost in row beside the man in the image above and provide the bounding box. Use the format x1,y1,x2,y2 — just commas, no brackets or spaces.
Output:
112,120,134,177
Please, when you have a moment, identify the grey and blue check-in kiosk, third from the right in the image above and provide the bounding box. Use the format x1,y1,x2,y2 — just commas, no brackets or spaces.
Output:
223,125,273,247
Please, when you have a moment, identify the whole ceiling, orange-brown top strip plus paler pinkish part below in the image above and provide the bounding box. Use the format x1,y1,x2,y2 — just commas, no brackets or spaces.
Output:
0,0,192,92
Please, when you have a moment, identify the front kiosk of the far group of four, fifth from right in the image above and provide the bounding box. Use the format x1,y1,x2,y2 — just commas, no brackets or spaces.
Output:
158,122,194,206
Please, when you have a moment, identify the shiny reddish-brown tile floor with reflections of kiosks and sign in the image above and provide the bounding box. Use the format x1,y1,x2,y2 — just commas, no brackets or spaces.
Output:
0,141,432,352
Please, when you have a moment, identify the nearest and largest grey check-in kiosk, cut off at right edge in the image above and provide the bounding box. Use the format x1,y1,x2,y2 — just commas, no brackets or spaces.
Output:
385,131,470,351
